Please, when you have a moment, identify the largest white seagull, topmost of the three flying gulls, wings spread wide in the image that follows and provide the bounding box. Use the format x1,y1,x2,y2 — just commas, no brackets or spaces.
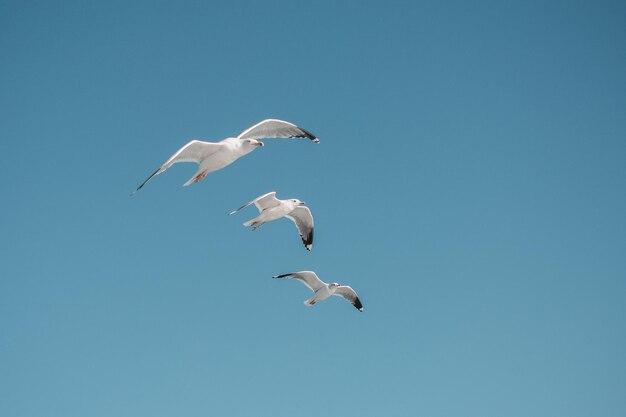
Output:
131,119,320,196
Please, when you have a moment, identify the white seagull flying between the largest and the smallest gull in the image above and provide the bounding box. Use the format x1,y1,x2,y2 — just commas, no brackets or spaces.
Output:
228,191,313,250
